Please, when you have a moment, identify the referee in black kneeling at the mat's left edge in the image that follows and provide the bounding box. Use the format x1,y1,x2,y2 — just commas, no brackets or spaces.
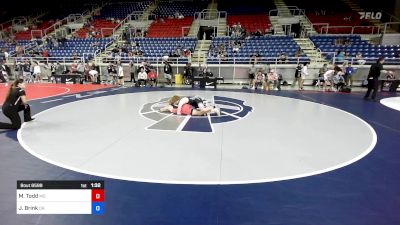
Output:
0,79,34,130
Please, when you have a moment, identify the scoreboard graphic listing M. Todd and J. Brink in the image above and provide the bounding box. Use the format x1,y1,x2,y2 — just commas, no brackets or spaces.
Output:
17,181,105,215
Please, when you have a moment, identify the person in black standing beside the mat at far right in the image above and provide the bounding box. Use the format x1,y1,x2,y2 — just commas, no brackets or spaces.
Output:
364,57,389,101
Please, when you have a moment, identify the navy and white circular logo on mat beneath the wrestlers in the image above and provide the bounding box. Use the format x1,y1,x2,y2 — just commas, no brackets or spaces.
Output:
139,96,253,132
